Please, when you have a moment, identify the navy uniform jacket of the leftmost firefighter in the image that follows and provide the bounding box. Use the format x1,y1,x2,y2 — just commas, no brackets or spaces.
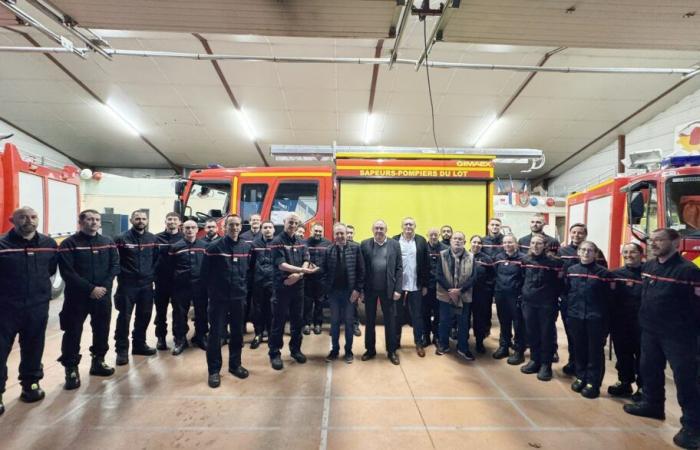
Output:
0,229,57,308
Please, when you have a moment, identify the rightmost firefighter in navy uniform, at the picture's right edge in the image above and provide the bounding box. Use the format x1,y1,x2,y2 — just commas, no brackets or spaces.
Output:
624,228,700,448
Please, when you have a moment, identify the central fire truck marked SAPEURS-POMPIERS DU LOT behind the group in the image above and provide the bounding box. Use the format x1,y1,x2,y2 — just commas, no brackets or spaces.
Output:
175,153,493,241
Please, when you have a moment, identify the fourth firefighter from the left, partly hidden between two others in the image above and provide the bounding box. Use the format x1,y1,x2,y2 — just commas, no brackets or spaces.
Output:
153,212,182,350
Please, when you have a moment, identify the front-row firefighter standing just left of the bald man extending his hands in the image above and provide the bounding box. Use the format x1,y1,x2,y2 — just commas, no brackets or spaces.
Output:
201,214,253,388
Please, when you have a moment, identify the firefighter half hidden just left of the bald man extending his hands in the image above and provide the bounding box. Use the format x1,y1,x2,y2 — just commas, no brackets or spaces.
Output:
250,220,275,350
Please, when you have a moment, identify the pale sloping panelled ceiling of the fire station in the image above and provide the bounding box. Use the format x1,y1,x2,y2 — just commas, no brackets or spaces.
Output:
0,0,700,177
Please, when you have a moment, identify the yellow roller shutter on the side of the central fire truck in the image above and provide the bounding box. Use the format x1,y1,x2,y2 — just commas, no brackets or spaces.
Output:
340,180,488,242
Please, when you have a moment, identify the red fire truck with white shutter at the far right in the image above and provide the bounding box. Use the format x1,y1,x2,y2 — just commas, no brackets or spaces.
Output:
566,155,700,268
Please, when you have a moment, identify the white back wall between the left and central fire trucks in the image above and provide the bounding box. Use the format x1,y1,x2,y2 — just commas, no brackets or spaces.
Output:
80,173,175,233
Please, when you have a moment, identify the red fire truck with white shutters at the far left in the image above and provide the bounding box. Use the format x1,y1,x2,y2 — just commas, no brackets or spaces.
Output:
0,143,80,298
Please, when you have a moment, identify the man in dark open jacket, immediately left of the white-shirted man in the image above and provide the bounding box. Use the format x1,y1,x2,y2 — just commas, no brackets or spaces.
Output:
360,220,403,365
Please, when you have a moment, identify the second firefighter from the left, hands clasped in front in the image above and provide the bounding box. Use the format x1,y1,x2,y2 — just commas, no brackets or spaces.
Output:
58,209,119,390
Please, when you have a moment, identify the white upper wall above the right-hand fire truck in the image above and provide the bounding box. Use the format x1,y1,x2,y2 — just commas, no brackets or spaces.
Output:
549,85,700,196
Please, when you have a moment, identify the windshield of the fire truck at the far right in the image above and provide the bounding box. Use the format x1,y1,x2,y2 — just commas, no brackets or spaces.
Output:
666,176,700,236
